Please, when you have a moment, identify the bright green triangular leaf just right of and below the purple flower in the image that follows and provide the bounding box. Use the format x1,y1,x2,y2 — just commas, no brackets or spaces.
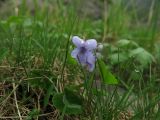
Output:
98,60,118,84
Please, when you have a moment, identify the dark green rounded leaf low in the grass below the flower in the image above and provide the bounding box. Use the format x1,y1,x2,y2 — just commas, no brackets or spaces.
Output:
52,88,83,115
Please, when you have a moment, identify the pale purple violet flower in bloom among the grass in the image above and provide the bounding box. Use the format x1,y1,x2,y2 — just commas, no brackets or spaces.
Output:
71,36,97,72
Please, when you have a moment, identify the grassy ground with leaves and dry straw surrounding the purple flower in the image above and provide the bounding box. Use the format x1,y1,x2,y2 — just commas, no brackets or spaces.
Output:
0,0,160,120
